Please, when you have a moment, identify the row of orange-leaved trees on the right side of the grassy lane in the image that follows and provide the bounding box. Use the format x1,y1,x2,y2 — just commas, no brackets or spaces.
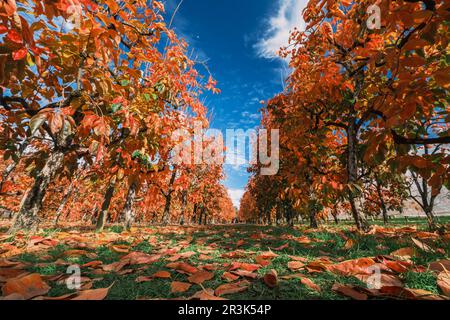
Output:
240,0,450,230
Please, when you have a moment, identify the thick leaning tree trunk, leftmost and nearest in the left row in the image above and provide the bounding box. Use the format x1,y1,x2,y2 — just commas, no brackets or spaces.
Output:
9,150,64,233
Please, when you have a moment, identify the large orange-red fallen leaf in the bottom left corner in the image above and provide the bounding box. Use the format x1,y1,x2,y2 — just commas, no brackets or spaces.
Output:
2,273,50,299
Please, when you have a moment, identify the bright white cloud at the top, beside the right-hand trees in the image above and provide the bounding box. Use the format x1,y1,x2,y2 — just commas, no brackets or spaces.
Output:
255,0,308,59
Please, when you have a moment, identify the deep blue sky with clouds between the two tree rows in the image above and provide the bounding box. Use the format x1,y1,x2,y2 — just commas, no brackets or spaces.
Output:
166,0,306,205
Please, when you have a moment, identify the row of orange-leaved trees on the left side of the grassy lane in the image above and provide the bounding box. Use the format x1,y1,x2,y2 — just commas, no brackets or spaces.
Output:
0,0,235,232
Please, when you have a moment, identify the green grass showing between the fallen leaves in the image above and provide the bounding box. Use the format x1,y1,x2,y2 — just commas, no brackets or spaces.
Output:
5,221,450,300
